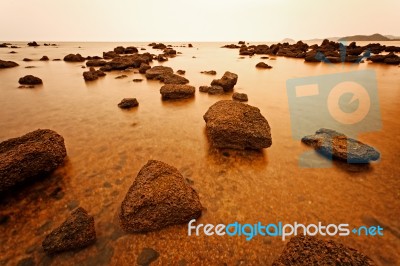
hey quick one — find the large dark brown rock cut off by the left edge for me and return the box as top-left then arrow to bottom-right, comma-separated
0,129 -> 67,191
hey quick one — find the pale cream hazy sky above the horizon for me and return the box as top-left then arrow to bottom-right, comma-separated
0,0 -> 400,42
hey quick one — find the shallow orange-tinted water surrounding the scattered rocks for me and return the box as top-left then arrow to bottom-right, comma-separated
0,42 -> 400,265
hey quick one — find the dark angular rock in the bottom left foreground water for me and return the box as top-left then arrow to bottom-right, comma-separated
42,207 -> 96,254
